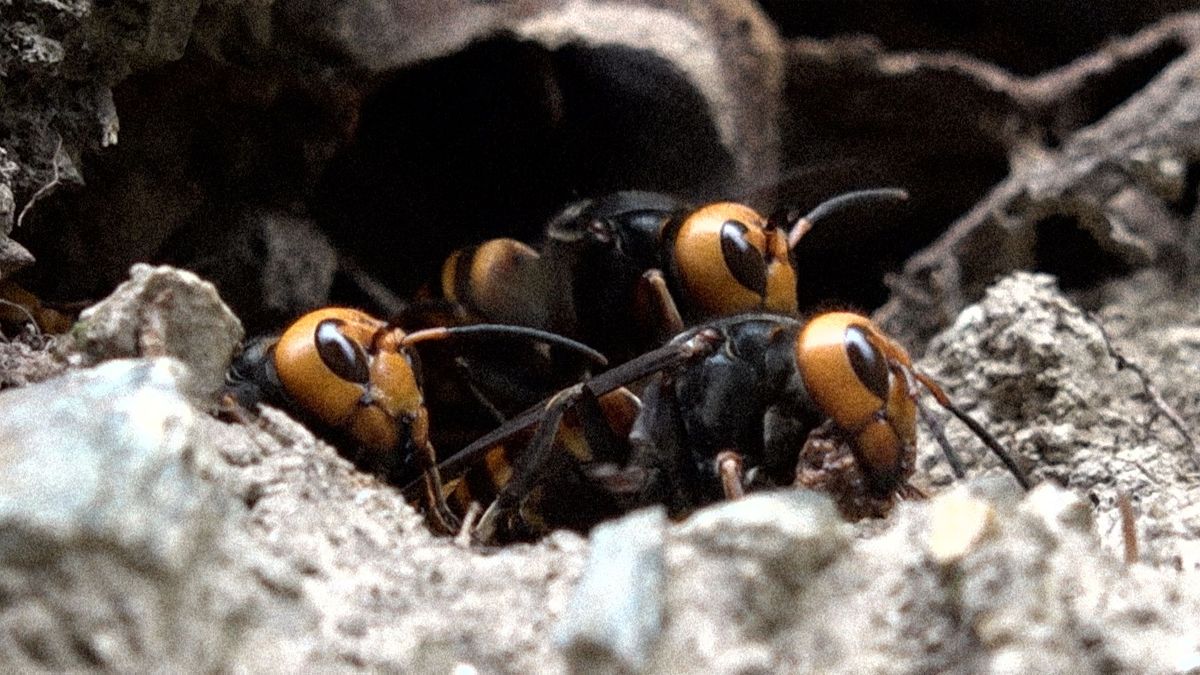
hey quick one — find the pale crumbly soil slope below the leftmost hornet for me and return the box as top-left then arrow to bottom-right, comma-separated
187,401 -> 586,673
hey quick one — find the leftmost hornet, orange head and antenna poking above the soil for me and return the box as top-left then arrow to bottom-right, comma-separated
226,307 -> 606,527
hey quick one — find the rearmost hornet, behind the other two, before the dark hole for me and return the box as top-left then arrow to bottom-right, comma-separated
427,189 -> 907,363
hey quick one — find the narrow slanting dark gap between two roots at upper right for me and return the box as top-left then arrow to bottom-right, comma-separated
1045,41 -> 1187,148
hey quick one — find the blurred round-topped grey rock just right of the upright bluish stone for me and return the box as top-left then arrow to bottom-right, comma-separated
650,490 -> 851,673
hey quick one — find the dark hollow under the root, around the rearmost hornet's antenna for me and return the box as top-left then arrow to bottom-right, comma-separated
781,60 -> 1008,310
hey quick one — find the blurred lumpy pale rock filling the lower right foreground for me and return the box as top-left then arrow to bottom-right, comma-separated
825,484 -> 1200,673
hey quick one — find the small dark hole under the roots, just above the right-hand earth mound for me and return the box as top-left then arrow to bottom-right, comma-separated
1034,214 -> 1130,285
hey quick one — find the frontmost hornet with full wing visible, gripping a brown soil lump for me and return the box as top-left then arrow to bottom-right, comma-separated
406,312 -> 1030,542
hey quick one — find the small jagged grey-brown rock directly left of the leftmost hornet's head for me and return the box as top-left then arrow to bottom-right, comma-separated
64,263 -> 242,396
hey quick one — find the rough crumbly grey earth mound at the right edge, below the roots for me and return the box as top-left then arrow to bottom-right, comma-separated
924,271 -> 1200,569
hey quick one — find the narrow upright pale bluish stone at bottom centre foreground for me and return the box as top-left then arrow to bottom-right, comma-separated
554,508 -> 667,673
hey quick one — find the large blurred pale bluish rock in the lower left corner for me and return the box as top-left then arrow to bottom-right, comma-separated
0,359 -> 247,670
